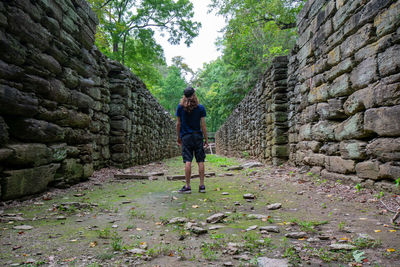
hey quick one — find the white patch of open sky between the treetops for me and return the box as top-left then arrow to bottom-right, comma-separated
156,0 -> 226,71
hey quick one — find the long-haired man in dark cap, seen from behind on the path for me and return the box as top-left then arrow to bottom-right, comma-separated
175,86 -> 208,194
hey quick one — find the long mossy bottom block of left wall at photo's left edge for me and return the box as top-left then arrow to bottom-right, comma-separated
1,164 -> 60,200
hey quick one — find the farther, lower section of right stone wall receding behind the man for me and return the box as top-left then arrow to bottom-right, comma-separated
216,57 -> 289,164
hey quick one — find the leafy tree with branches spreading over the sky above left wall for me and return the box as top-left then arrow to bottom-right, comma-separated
89,0 -> 201,63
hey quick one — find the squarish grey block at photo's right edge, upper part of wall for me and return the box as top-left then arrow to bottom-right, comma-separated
378,44 -> 400,77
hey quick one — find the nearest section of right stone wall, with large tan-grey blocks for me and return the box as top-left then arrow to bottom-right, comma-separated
217,0 -> 400,193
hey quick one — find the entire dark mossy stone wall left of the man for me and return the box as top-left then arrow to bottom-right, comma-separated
0,0 -> 179,200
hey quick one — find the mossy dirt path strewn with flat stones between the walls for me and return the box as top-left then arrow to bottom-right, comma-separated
0,156 -> 400,267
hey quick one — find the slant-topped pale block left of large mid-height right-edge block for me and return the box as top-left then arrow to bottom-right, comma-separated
335,113 -> 371,141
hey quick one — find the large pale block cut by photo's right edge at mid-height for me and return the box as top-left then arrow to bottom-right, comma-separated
364,105 -> 400,136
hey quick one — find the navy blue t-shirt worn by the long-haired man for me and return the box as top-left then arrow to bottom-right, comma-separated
175,104 -> 206,137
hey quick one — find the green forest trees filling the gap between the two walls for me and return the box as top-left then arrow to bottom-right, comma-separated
89,0 -> 306,132
